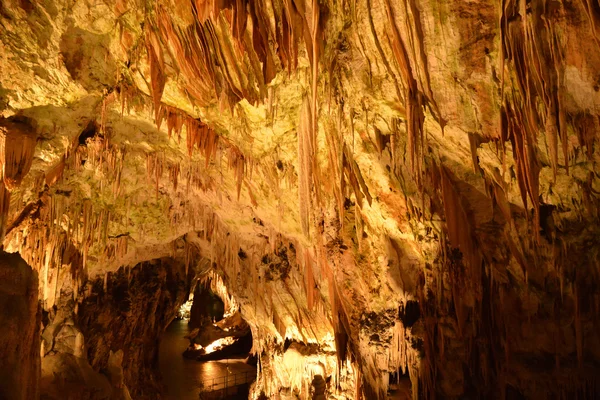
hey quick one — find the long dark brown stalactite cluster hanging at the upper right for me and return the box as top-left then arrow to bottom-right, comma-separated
500,0 -> 569,241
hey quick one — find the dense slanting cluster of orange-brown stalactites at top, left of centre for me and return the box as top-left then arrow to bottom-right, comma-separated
157,0 -> 310,105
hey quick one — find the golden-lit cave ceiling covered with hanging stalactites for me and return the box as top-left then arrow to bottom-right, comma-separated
0,0 -> 600,394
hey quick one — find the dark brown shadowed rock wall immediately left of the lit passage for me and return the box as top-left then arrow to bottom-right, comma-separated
77,258 -> 190,399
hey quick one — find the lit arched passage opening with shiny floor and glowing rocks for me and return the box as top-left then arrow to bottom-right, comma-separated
159,274 -> 256,399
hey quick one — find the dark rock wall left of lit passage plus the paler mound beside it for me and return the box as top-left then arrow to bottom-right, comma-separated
38,253 -> 193,400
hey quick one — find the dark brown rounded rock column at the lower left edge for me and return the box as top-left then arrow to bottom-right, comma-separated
0,251 -> 41,400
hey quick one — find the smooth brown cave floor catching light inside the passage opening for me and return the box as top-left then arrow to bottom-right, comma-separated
158,320 -> 256,400
